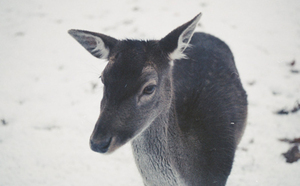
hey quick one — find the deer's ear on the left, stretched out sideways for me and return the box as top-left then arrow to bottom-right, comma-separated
68,30 -> 118,59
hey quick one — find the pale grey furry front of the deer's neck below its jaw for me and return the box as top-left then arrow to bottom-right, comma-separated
132,76 -> 181,185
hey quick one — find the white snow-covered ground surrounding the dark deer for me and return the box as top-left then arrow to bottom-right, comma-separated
0,0 -> 300,186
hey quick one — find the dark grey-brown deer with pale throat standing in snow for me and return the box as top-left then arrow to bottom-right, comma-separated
68,13 -> 248,186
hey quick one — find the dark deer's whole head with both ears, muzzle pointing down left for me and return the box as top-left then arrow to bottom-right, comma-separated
69,14 -> 201,153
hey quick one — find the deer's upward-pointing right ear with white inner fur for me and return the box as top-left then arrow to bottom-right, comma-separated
159,13 -> 201,60
